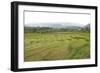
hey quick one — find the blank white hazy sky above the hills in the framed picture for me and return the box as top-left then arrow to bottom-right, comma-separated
24,12 -> 90,26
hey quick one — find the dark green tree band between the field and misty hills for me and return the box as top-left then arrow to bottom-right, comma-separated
24,24 -> 90,33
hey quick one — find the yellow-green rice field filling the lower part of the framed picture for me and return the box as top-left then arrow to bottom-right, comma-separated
24,32 -> 90,62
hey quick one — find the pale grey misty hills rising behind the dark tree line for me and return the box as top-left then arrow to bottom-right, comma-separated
25,23 -> 83,28
